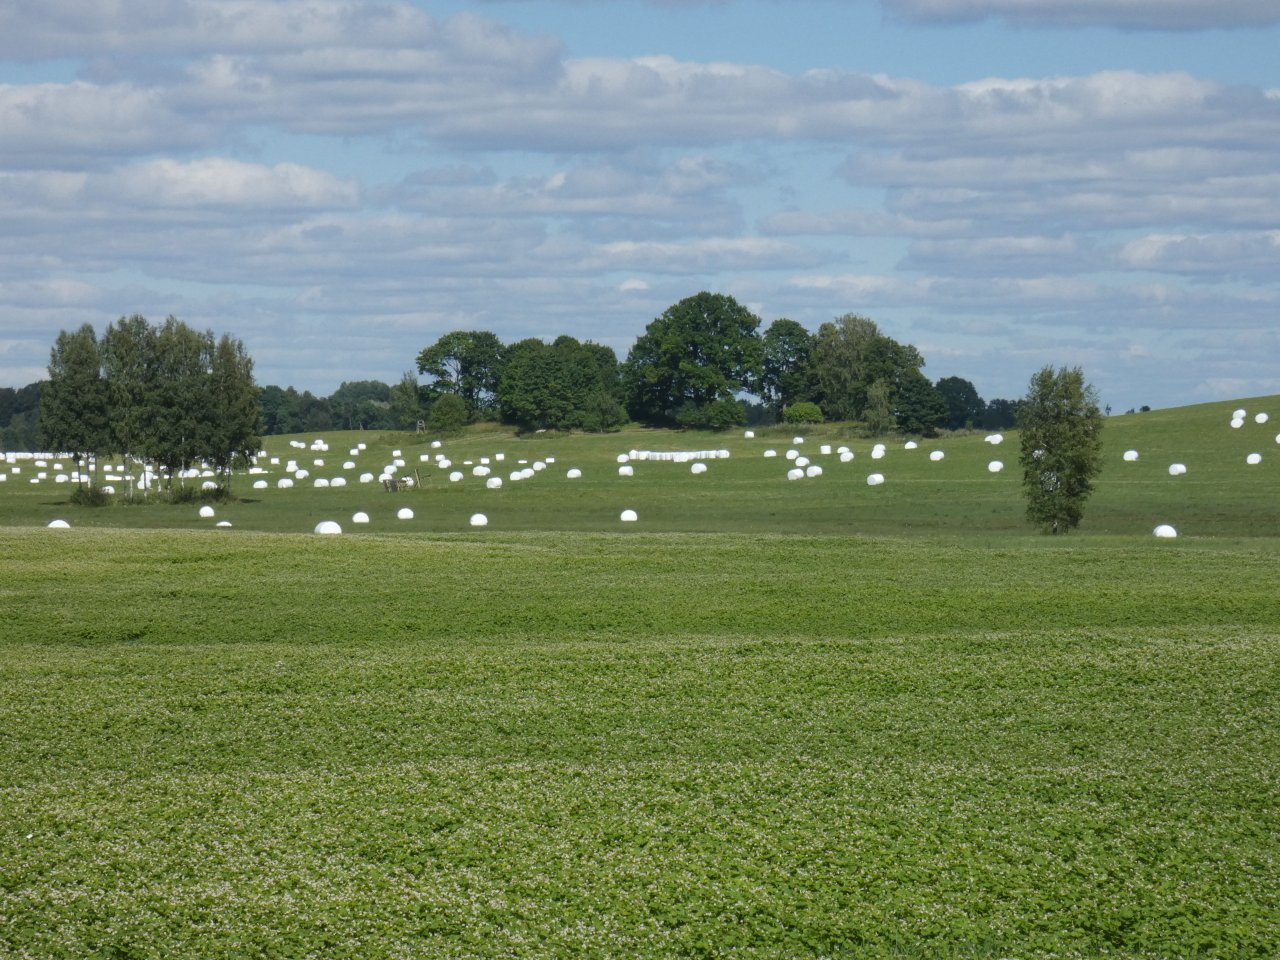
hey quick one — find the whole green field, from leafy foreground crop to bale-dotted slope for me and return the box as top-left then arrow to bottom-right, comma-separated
0,398 -> 1280,959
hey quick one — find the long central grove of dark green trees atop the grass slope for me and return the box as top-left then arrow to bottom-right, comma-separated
391,292 -> 1018,435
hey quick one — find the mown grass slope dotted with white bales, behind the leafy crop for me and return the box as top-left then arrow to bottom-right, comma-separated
0,397 -> 1280,538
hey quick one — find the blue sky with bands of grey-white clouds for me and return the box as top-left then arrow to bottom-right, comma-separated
0,0 -> 1280,412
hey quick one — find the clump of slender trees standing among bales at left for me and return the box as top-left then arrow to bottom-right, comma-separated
38,315 -> 261,491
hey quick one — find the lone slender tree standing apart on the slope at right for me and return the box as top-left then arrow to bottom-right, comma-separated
1018,366 -> 1102,534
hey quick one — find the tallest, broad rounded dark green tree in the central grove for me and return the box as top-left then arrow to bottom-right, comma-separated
623,292 -> 763,425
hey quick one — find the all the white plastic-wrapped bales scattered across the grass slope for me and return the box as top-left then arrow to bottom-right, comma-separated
17,410 -> 1280,538
